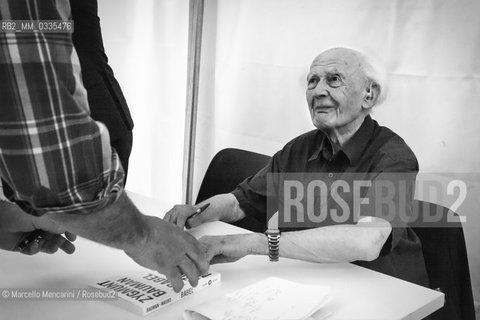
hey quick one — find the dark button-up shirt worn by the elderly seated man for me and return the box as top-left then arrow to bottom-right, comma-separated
233,116 -> 428,286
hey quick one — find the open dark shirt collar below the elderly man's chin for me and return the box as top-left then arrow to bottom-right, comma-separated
308,115 -> 375,164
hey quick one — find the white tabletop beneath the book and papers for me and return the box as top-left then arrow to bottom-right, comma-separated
0,194 -> 444,320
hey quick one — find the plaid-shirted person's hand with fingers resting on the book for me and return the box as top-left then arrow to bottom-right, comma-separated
125,216 -> 209,292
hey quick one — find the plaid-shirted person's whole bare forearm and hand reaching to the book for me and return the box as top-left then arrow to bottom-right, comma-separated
43,191 -> 209,292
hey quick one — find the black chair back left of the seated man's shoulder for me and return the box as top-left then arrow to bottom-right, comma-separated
196,148 -> 270,232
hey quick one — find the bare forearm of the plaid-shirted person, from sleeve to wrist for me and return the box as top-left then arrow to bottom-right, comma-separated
47,191 -> 149,251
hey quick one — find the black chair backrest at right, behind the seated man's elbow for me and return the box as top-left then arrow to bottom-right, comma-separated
411,200 -> 475,320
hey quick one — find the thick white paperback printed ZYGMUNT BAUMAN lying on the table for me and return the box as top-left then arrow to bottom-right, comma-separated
90,272 -> 220,315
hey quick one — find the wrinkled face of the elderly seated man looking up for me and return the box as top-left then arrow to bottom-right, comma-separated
306,49 -> 367,130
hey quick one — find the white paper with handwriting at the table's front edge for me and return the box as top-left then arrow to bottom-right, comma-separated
184,277 -> 329,320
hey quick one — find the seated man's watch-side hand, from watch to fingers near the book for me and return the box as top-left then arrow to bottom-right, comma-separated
199,233 -> 268,264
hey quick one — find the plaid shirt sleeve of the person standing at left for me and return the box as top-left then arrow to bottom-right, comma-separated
0,0 -> 124,216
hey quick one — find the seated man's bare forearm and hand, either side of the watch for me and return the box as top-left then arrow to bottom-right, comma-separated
212,219 -> 391,263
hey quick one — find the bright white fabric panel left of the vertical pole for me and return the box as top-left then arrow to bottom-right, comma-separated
98,0 -> 188,205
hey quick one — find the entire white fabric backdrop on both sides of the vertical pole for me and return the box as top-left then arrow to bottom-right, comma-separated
99,0 -> 480,316
